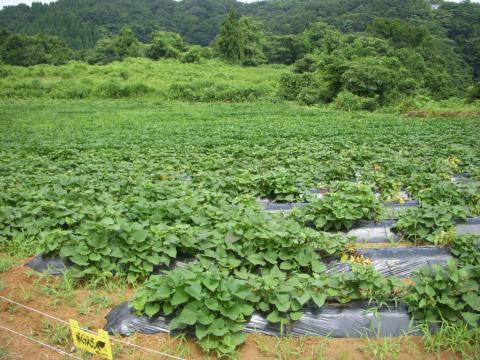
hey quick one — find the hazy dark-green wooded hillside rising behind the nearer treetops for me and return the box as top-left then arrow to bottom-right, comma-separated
0,0 -> 438,48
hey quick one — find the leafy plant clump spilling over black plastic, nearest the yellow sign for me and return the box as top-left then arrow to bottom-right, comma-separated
133,265 -> 259,355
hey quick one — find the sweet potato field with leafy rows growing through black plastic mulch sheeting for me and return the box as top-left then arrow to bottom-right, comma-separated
0,100 -> 480,358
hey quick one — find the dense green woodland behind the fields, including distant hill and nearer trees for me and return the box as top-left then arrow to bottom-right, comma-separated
0,0 -> 480,110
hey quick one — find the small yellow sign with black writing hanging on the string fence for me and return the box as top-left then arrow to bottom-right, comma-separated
70,320 -> 113,360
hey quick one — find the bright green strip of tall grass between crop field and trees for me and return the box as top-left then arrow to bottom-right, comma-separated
0,58 -> 287,101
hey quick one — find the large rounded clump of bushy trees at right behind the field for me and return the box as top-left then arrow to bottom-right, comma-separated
280,19 -> 470,106
